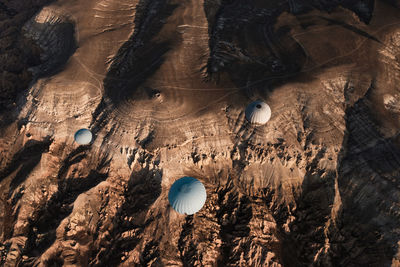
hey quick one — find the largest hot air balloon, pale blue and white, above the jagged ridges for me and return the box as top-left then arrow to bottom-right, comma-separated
168,176 -> 207,215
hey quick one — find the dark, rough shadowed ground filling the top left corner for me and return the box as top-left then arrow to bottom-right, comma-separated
0,0 -> 56,124
